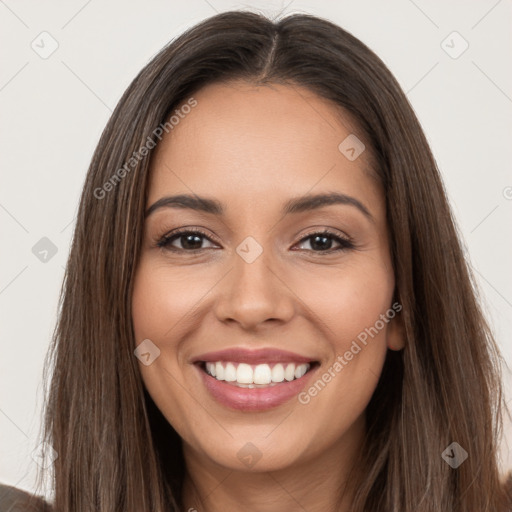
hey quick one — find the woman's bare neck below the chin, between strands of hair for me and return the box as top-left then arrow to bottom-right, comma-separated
182,418 -> 364,512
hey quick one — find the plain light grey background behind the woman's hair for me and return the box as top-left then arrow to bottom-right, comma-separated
0,0 -> 512,498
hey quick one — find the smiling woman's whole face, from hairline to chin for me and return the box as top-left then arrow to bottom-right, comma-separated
132,82 -> 403,471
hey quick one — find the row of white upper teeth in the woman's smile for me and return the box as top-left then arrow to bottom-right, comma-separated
206,361 -> 311,388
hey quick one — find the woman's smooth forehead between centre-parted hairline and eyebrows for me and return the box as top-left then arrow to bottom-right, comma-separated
148,81 -> 379,217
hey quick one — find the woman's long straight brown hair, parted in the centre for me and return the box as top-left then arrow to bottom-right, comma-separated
34,12 -> 505,512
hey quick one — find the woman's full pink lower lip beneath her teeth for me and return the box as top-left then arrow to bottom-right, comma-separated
196,365 -> 317,411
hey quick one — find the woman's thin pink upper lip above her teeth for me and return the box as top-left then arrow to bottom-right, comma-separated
192,347 -> 315,364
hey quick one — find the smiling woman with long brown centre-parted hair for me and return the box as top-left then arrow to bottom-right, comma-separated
6,8 -> 512,512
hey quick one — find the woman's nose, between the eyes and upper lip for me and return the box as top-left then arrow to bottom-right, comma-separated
214,245 -> 295,330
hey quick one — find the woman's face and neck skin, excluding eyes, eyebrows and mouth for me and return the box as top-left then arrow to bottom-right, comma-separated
132,82 -> 404,512
